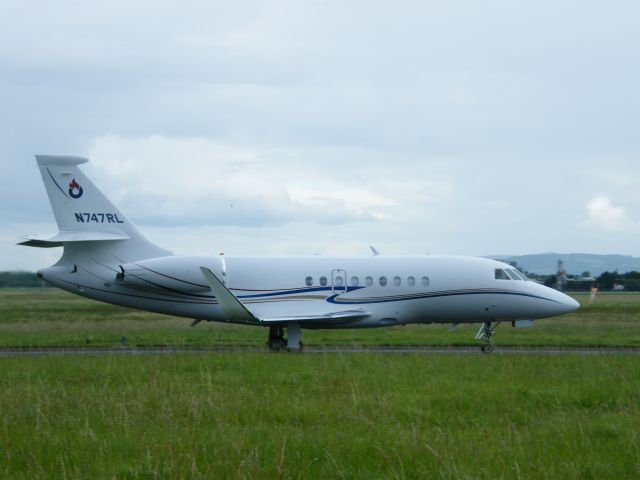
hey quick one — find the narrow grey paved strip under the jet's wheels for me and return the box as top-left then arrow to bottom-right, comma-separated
0,346 -> 640,358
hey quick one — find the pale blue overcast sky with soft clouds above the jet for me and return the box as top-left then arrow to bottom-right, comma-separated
0,0 -> 640,270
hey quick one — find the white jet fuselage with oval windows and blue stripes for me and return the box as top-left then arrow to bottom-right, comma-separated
41,255 -> 578,328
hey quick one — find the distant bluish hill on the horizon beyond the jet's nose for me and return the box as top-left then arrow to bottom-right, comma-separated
490,253 -> 640,276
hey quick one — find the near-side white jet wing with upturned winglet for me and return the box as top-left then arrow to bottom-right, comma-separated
200,267 -> 370,325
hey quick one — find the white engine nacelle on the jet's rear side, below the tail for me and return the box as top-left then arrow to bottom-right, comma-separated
116,257 -> 223,293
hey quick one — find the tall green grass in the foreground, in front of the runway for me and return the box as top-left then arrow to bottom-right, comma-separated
0,353 -> 640,479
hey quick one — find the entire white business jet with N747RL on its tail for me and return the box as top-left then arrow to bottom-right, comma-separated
20,155 -> 579,352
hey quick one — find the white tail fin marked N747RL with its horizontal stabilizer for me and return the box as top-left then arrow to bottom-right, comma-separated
21,155 -> 171,261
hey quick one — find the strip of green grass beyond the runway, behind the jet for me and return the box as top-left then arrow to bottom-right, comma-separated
0,288 -> 640,348
